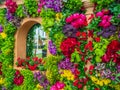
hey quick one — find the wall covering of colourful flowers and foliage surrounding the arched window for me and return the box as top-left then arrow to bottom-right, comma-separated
0,0 -> 120,90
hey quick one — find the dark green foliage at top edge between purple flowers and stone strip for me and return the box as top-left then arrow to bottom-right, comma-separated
64,0 -> 82,11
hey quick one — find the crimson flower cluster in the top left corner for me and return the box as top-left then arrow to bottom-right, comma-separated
5,0 -> 17,13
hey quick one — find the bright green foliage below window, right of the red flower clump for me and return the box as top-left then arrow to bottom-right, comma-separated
13,70 -> 35,90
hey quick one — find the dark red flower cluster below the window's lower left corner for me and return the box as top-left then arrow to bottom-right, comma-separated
14,70 -> 24,86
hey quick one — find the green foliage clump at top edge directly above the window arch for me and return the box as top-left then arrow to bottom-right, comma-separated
24,0 -> 38,17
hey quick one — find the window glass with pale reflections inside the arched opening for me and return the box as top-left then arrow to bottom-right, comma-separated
26,24 -> 47,58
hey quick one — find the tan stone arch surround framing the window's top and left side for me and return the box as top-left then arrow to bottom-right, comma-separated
14,18 -> 48,70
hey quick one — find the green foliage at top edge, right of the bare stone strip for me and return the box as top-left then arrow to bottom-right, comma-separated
91,0 -> 115,11
